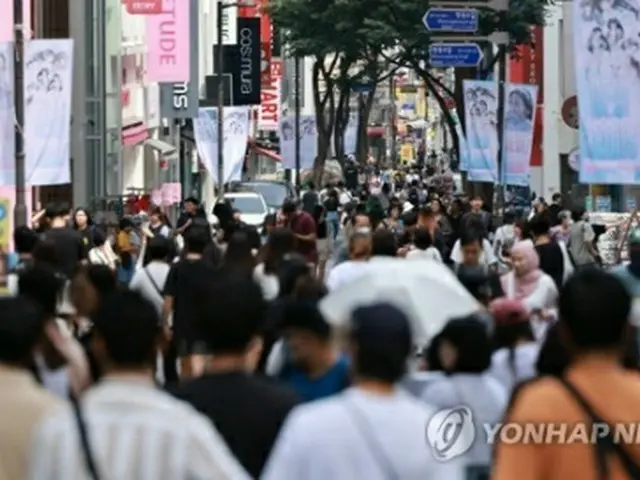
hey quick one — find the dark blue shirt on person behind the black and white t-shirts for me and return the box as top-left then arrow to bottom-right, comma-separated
280,355 -> 350,402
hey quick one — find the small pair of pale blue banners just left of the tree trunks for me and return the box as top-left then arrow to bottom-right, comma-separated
280,115 -> 318,170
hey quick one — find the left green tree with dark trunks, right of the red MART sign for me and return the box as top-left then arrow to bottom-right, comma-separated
270,0 -> 395,175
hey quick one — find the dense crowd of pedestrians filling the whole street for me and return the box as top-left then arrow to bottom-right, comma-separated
0,168 -> 640,480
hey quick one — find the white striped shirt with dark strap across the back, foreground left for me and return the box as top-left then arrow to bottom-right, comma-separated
29,376 -> 250,480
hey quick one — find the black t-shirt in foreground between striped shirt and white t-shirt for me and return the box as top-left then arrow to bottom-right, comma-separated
171,372 -> 300,478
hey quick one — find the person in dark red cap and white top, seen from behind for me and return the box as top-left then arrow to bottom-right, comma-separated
489,298 -> 540,392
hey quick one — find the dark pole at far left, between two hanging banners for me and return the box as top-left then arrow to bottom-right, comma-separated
13,0 -> 28,228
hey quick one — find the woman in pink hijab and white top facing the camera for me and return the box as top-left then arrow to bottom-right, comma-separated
500,240 -> 558,338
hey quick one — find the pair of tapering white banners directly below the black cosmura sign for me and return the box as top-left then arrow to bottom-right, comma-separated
193,107 -> 249,183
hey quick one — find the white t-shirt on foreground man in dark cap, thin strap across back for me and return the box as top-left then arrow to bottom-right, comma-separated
261,388 -> 464,480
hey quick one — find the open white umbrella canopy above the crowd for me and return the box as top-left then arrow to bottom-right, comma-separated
320,258 -> 481,346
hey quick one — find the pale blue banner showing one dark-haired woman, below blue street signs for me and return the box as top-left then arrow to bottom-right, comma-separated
502,83 -> 538,187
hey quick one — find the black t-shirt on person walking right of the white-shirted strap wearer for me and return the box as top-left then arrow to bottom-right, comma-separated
163,258 -> 218,345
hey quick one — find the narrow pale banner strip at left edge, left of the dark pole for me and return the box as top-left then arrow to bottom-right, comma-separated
0,42 -> 15,185
